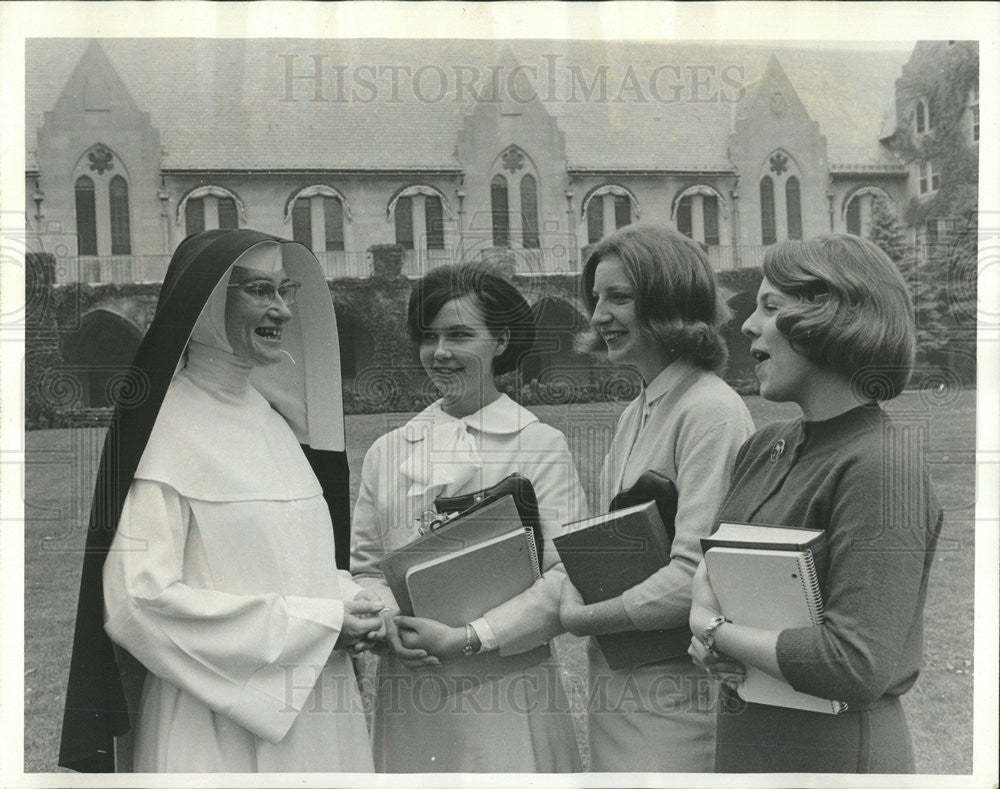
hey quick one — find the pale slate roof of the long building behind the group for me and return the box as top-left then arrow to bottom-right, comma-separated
25,39 -> 908,171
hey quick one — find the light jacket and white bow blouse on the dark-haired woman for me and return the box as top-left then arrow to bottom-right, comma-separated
351,395 -> 587,654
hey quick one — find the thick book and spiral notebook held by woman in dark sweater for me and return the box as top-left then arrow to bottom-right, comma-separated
701,523 -> 847,714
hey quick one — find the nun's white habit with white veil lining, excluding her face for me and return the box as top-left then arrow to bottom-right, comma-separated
64,231 -> 372,772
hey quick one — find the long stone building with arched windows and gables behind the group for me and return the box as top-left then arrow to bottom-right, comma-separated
25,39 -> 960,405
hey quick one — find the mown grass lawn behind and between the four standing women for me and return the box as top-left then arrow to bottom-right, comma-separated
24,391 -> 975,774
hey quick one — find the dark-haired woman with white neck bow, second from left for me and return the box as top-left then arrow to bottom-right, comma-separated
351,264 -> 586,773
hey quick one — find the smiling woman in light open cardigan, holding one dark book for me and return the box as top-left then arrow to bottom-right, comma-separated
561,225 -> 753,772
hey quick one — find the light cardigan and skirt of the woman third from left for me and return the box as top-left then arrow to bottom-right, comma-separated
587,360 -> 753,773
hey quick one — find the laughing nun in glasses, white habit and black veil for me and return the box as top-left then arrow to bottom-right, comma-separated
59,230 -> 381,772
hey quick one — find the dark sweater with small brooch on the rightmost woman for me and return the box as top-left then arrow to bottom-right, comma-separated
719,405 -> 941,709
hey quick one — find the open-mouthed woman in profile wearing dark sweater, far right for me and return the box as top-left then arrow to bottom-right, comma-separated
690,235 -> 941,773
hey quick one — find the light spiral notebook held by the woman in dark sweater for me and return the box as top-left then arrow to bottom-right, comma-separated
705,548 -> 847,714
